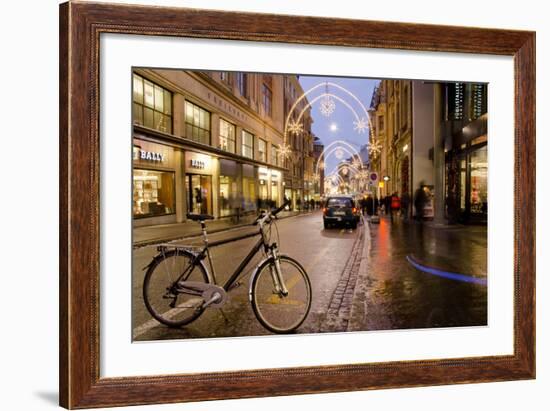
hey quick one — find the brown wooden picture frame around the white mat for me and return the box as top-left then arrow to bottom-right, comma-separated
59,2 -> 535,409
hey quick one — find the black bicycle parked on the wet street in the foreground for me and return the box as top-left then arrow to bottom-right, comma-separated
143,202 -> 312,334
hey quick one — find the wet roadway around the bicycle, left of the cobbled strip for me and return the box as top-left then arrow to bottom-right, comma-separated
133,211 -> 364,340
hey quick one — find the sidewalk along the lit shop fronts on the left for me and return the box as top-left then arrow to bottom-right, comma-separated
132,211 -> 310,248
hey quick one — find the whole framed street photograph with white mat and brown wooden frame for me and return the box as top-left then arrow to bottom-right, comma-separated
60,2 -> 535,409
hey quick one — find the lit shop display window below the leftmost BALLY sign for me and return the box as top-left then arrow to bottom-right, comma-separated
133,169 -> 175,217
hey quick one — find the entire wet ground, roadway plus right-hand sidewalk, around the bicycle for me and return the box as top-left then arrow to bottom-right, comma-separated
132,211 -> 487,341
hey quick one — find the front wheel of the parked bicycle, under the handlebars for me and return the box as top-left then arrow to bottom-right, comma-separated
251,256 -> 312,334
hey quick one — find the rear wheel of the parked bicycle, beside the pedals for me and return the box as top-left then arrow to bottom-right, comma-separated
143,250 -> 210,327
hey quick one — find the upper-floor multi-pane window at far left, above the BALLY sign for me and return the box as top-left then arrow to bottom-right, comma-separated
133,74 -> 172,133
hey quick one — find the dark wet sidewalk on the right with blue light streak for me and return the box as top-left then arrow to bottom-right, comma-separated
360,217 -> 487,330
